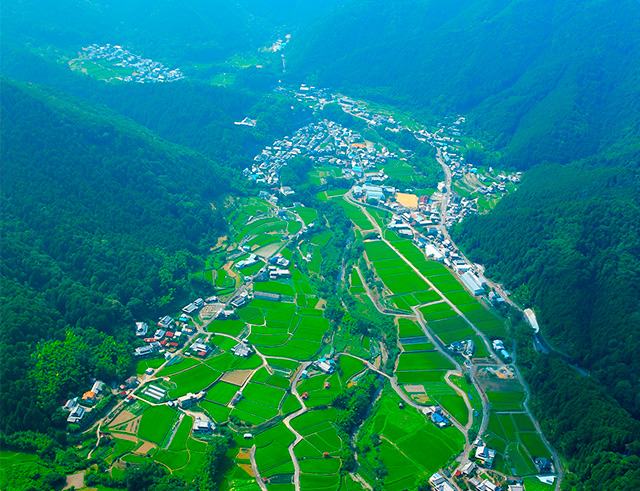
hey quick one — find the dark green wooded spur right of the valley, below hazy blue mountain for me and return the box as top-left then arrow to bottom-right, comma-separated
457,160 -> 640,417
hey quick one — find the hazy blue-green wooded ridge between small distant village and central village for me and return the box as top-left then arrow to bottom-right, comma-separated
1,44 -> 309,168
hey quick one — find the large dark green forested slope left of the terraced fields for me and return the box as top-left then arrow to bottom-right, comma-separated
0,81 -> 232,432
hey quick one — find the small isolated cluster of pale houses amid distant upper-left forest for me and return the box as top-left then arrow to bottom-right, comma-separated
74,44 -> 184,83
